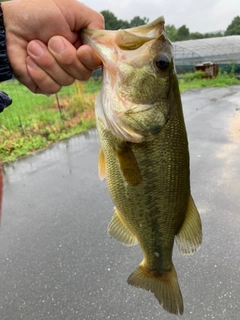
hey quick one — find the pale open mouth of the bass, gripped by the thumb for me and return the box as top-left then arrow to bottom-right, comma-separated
81,16 -> 165,64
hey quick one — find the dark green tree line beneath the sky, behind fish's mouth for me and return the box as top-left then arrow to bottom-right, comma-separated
101,10 -> 240,41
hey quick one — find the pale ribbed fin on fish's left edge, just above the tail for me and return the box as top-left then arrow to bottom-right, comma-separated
108,208 -> 137,246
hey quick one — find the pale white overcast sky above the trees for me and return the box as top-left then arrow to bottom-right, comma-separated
84,0 -> 240,33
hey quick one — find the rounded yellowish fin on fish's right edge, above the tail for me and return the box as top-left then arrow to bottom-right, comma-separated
176,195 -> 202,255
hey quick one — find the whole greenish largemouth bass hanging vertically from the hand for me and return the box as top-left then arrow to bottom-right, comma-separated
83,17 -> 202,314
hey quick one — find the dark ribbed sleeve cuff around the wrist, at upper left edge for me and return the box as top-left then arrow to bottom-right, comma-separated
0,2 -> 12,82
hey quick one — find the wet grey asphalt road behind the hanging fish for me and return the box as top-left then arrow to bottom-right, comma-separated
0,87 -> 240,320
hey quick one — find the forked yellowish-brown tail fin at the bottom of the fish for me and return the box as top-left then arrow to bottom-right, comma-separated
128,263 -> 183,314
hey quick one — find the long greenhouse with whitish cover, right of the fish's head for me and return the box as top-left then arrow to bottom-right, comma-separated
173,35 -> 240,73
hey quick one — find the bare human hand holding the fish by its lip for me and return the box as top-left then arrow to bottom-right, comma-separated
2,0 -> 104,94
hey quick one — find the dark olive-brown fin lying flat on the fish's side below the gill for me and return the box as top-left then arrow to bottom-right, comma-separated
115,142 -> 142,185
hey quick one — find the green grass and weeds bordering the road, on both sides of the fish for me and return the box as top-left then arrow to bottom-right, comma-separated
0,66 -> 240,162
